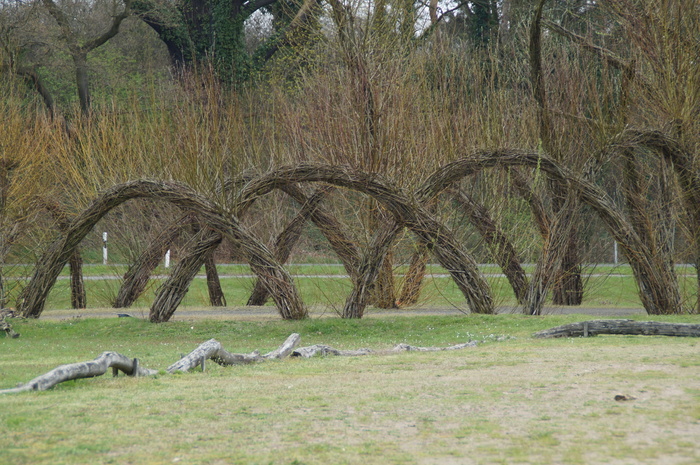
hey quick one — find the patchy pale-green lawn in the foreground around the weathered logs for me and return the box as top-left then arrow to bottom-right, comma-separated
0,315 -> 700,465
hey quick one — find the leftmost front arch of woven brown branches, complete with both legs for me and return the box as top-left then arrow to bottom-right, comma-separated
18,180 -> 307,319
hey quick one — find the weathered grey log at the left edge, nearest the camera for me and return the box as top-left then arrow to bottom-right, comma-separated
0,352 -> 158,394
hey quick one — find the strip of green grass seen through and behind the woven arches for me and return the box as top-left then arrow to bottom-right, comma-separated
7,264 -> 696,311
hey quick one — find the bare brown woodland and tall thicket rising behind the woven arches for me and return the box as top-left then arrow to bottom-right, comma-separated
0,0 -> 700,321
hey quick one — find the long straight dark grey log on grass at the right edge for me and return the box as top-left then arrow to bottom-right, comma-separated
532,320 -> 700,338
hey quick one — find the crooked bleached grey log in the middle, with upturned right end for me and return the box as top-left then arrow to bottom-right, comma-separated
167,333 -> 301,373
